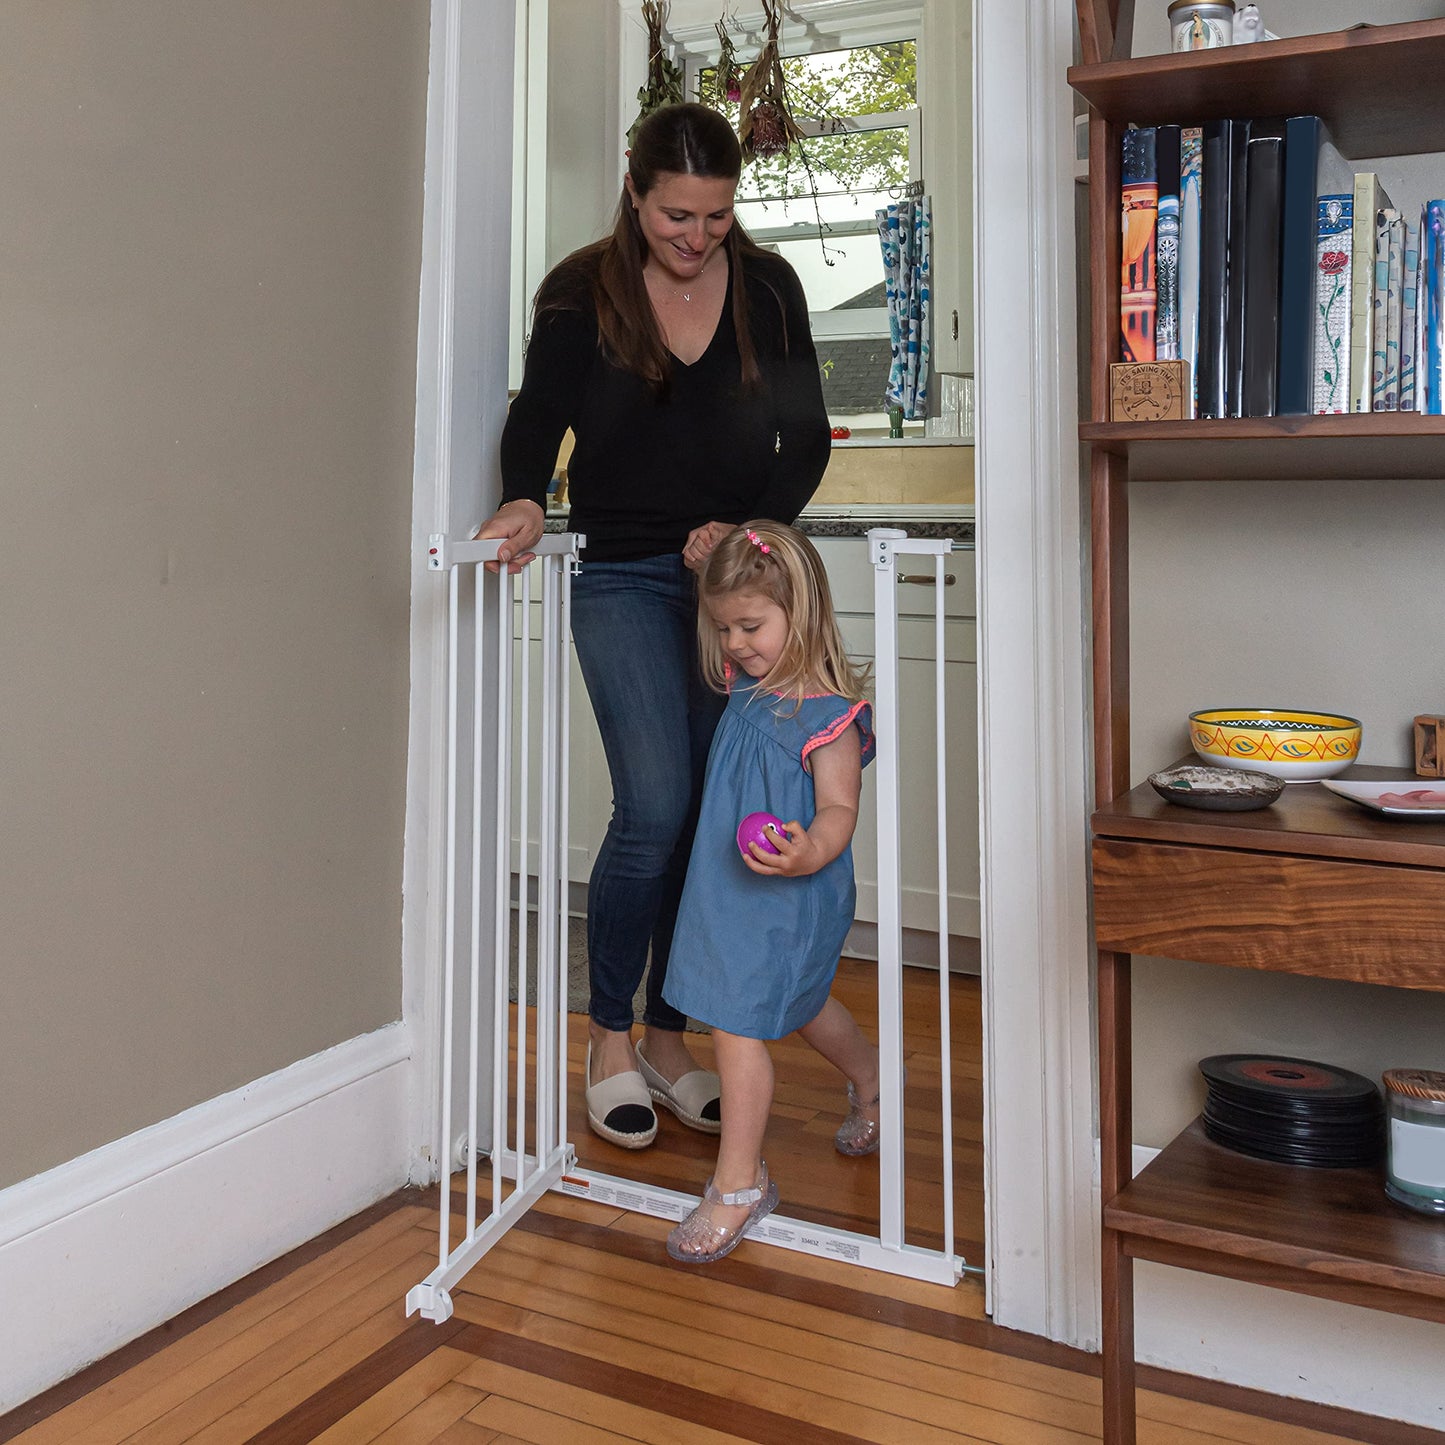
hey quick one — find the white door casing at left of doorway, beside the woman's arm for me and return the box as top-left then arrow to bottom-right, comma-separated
402,0 -> 516,1183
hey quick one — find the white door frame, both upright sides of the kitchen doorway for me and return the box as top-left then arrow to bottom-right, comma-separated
403,0 -> 1097,1345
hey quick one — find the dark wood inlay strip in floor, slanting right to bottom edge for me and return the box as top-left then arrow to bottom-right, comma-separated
447,1325 -> 863,1445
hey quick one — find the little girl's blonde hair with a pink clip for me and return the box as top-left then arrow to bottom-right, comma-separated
698,519 -> 868,704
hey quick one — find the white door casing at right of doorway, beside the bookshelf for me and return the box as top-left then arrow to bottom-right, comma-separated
974,0 -> 1097,1347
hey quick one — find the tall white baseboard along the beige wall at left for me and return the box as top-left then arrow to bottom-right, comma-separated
0,1023 -> 412,1412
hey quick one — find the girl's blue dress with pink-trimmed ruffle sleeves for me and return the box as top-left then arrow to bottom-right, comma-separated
663,679 -> 873,1039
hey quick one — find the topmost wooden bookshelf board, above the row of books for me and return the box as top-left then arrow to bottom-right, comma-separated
1068,20 -> 1445,158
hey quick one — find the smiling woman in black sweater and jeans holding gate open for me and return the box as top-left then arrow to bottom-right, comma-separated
478,104 -> 829,1149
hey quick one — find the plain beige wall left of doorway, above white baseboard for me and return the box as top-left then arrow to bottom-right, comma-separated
0,0 -> 428,1186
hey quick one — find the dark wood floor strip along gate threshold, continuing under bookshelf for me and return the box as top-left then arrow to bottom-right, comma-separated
517,1211 -> 1445,1445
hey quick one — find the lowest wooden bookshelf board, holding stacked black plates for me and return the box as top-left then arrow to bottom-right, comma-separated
1104,1120 -> 1445,1321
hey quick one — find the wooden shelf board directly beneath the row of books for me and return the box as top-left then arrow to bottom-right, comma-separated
1079,416 -> 1445,481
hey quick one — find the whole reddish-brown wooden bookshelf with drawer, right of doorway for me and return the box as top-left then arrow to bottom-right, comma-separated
1069,0 -> 1445,1445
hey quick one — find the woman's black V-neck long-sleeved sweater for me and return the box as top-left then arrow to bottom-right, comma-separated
501,245 -> 829,561
